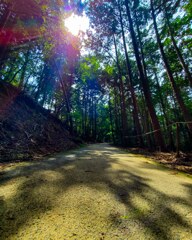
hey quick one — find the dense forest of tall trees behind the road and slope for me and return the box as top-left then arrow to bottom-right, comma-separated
0,0 -> 192,151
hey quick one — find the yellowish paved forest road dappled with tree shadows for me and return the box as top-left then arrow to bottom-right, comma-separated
0,144 -> 192,240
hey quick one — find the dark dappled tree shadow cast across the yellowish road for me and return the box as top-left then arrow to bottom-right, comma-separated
0,144 -> 192,240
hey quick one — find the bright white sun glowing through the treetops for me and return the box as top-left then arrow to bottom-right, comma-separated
64,14 -> 89,36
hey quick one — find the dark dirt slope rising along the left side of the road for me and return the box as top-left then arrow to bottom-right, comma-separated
0,82 -> 76,162
